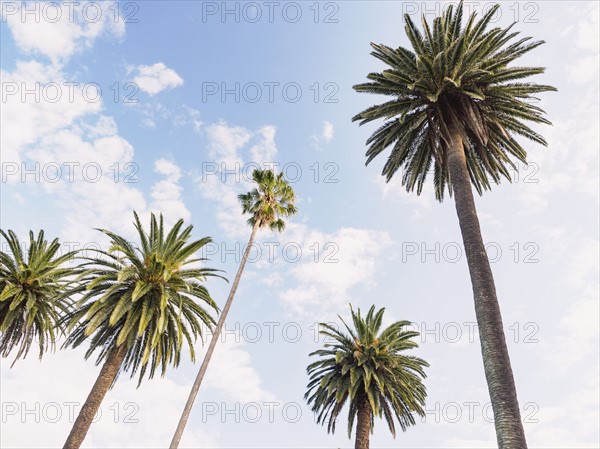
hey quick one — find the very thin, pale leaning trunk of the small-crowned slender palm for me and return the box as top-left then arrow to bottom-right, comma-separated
170,221 -> 259,449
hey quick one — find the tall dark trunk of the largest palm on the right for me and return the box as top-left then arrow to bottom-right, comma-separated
448,129 -> 527,449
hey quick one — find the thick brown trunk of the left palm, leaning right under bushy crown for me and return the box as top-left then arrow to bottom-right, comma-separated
63,344 -> 127,449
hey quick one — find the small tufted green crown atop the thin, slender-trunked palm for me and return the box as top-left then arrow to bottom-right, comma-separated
238,169 -> 297,232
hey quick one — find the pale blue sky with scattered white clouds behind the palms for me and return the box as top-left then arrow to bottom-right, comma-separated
0,1 -> 600,448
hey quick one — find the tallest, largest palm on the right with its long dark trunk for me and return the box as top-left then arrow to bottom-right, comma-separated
353,3 -> 556,449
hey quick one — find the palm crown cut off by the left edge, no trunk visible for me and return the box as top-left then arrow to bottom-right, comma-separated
0,229 -> 76,367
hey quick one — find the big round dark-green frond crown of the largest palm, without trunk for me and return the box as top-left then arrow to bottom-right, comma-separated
352,2 -> 556,201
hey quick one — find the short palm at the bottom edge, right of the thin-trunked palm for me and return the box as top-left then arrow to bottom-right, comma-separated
304,306 -> 429,449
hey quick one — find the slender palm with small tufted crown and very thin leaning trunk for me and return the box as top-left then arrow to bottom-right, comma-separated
170,169 -> 296,449
